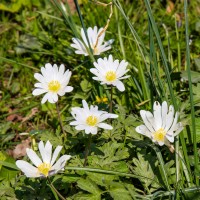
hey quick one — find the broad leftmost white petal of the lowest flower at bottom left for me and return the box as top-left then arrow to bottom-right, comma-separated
16,160 -> 40,177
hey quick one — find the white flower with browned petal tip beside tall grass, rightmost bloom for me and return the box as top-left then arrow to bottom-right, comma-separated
136,101 -> 183,146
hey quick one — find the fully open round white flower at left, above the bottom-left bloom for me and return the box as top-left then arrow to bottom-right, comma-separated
32,63 -> 73,104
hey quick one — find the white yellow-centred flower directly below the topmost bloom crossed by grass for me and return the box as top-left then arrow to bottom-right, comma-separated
90,55 -> 130,92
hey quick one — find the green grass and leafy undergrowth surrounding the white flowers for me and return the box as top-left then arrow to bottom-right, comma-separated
0,0 -> 200,200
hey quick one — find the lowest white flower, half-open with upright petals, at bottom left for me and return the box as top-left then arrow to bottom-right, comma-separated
16,141 -> 71,177
